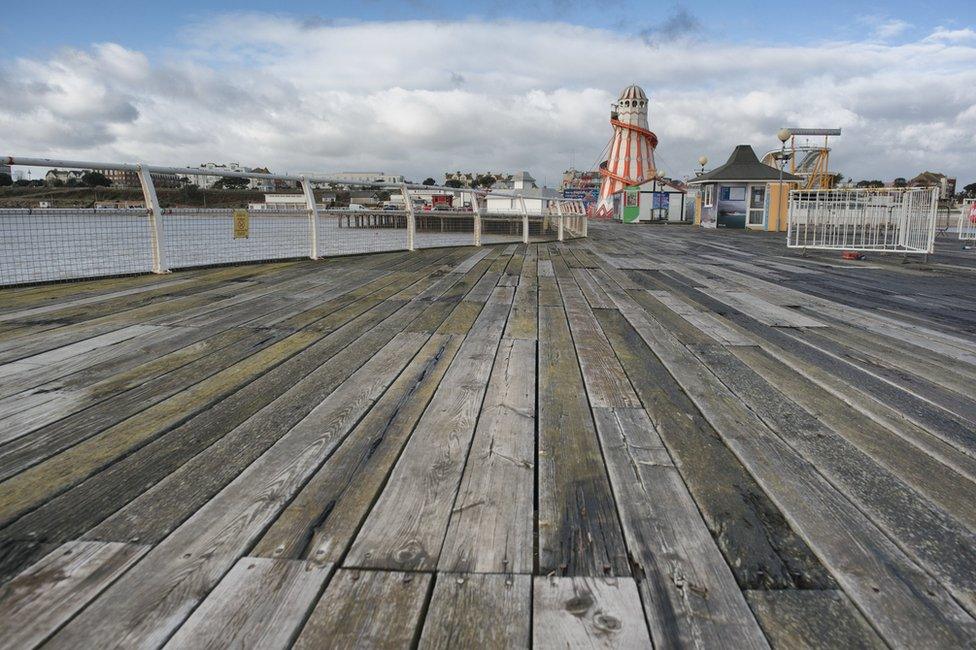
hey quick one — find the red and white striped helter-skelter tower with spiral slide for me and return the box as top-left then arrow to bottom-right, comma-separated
593,86 -> 657,219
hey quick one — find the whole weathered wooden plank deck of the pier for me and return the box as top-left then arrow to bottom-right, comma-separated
0,224 -> 976,649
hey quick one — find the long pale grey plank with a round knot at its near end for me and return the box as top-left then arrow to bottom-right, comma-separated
345,287 -> 513,570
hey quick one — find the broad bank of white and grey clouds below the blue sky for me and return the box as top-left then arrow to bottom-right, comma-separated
0,13 -> 976,183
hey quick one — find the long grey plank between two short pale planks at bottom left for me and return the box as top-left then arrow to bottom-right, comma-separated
44,334 -> 426,647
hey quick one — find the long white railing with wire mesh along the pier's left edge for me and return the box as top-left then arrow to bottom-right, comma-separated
0,157 -> 587,286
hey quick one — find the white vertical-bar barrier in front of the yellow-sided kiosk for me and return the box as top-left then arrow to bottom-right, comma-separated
787,188 -> 938,253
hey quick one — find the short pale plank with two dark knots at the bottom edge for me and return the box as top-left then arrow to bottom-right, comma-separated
532,576 -> 652,648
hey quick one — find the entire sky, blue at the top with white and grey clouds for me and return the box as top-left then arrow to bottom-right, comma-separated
0,0 -> 976,184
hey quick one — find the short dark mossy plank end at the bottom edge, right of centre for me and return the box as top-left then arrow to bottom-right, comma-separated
745,589 -> 887,650
